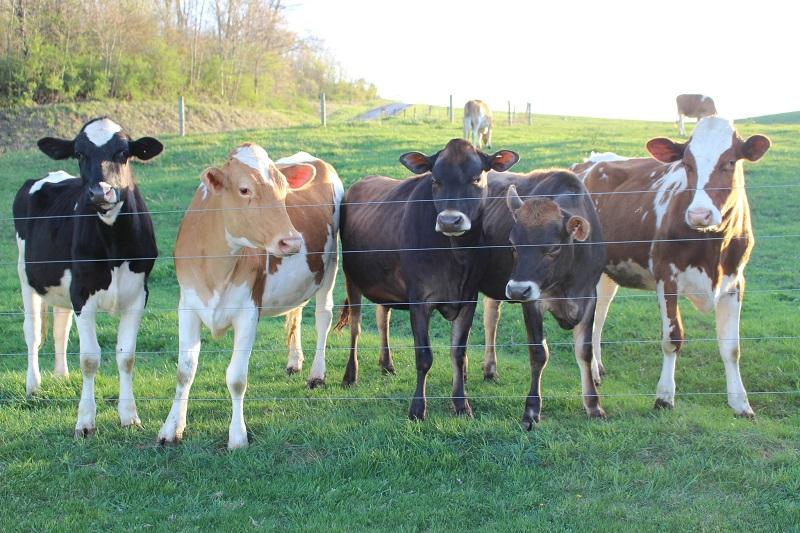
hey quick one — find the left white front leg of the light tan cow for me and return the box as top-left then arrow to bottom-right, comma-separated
158,306 -> 201,445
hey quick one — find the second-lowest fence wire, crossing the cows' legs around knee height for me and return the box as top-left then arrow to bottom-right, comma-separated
0,335 -> 800,357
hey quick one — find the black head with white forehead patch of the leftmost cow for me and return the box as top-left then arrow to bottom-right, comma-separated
37,117 -> 164,224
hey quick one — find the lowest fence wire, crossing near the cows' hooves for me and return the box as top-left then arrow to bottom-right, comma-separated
0,389 -> 800,404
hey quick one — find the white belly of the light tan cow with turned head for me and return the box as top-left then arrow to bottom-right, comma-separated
261,247 -> 329,316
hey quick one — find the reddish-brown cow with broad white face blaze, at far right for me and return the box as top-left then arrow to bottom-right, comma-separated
575,117 -> 770,416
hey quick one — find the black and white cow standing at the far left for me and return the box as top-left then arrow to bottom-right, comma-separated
14,117 -> 163,436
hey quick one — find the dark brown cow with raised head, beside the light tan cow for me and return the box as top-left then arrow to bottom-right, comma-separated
339,139 -> 519,420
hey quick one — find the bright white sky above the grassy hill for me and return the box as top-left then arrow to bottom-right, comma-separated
287,0 -> 800,120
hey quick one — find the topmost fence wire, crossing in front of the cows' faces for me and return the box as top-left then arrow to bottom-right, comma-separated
7,180 -> 800,222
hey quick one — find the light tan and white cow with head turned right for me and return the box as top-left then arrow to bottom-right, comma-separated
158,143 -> 344,449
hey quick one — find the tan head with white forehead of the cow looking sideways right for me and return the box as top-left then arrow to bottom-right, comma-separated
201,143 -> 306,257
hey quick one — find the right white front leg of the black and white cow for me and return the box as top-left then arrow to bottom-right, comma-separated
117,291 -> 145,427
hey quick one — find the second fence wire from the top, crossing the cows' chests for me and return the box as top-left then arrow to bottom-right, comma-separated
0,233 -> 800,266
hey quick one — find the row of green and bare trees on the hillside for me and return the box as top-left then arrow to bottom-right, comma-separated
0,0 -> 377,107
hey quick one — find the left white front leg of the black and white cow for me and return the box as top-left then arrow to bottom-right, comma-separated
75,302 -> 100,438
